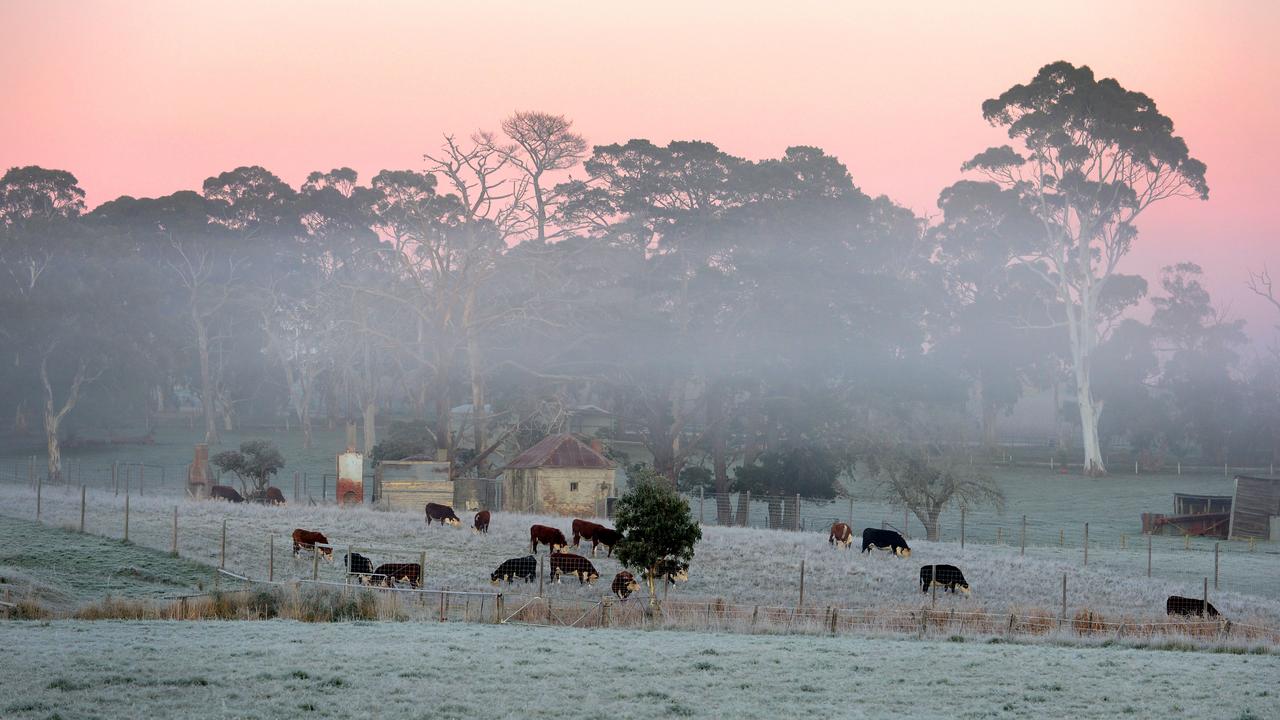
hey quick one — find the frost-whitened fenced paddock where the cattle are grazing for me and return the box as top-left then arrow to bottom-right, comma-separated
0,484 -> 1280,628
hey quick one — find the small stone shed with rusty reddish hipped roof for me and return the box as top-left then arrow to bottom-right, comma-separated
502,433 -> 616,518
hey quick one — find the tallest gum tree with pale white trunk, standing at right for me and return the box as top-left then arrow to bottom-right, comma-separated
961,61 -> 1208,475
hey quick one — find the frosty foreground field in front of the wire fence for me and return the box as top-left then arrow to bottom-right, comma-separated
0,620 -> 1280,720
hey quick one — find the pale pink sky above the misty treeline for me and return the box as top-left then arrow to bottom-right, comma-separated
0,0 -> 1280,336
